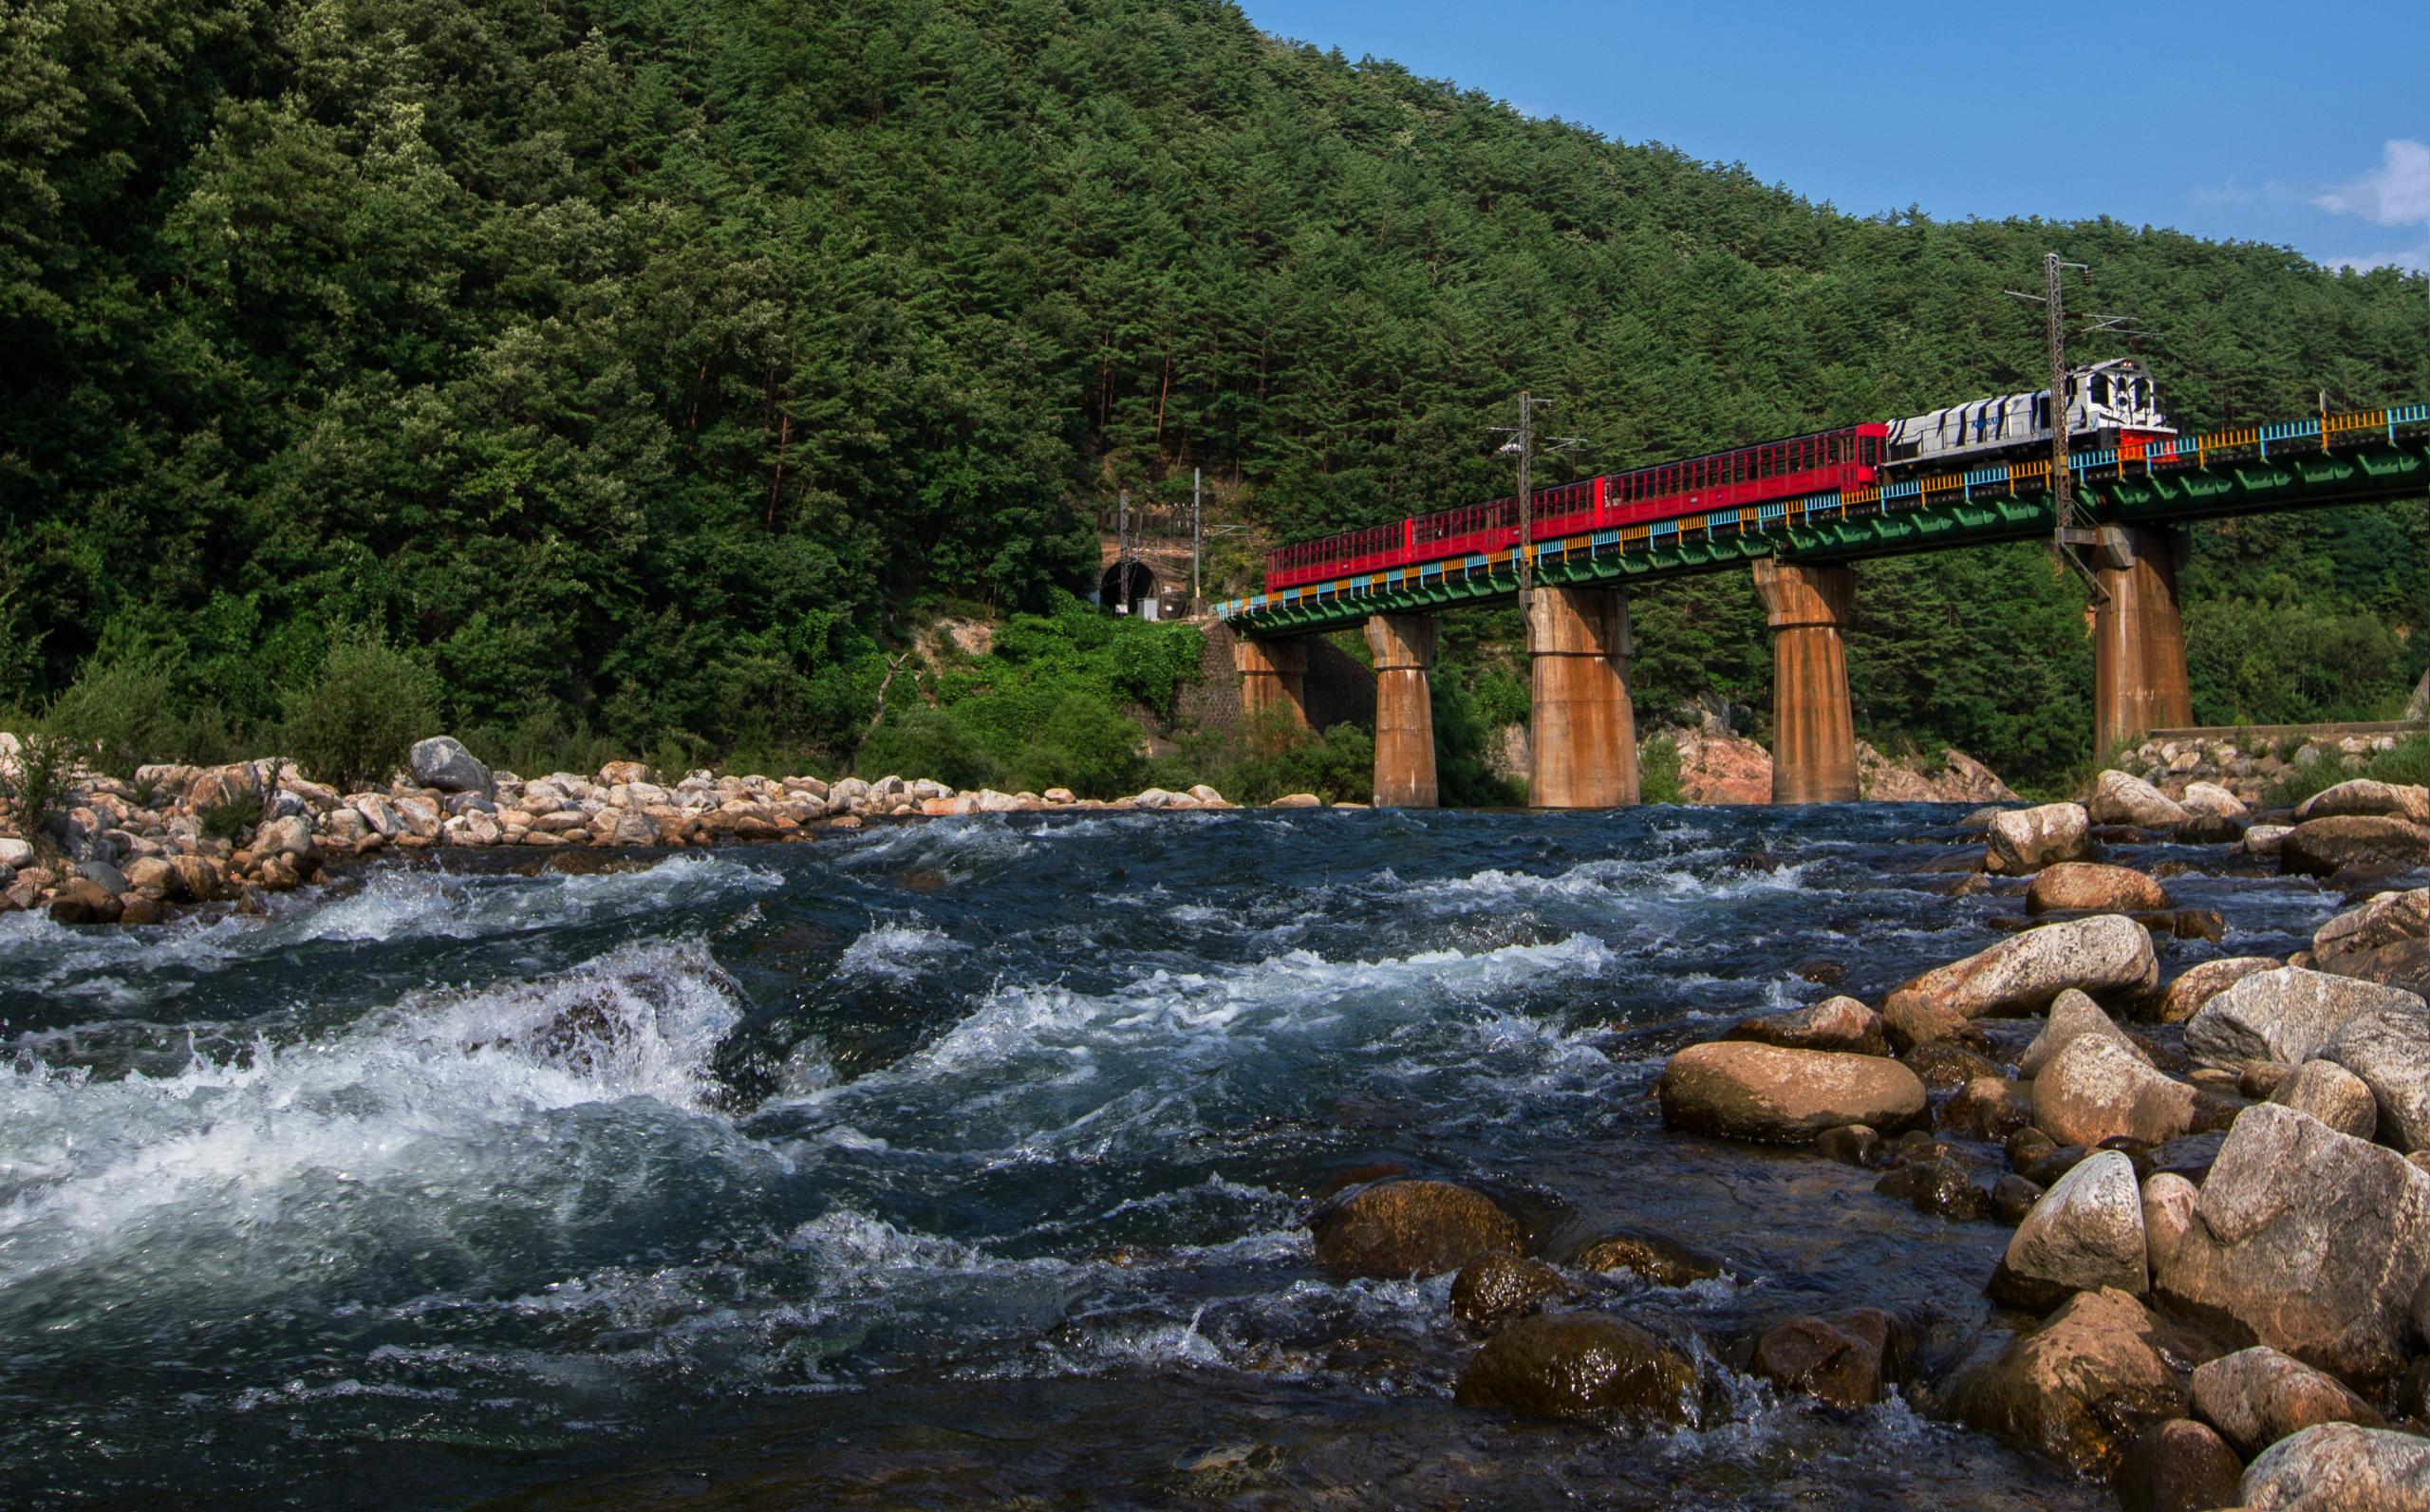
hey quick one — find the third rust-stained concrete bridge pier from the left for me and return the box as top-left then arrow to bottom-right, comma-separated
1526,588 -> 1637,810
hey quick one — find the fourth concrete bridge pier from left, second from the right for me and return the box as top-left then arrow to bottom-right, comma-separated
1754,556 -> 1857,802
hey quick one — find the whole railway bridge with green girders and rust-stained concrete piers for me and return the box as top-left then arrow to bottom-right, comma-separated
1215,403 -> 2430,810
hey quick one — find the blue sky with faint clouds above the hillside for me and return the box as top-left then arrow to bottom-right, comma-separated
1244,0 -> 2430,270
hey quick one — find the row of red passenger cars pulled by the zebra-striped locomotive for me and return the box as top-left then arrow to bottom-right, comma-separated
1266,425 -> 1888,593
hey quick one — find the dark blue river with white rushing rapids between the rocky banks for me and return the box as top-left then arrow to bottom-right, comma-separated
0,807 -> 2333,1507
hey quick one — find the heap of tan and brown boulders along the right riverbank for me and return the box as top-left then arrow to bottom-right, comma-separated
1310,771 -> 2430,1512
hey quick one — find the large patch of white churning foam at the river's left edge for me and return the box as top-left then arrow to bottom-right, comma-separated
0,943 -> 741,1300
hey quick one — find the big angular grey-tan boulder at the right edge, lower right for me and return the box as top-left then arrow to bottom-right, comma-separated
2156,1104 -> 2430,1378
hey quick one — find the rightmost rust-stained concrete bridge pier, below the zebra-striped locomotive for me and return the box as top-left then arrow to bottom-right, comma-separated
2092,525 -> 2195,756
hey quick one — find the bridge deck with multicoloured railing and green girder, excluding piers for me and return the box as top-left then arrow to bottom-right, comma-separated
1215,403 -> 2430,634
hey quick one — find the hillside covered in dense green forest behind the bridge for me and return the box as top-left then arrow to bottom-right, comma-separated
0,0 -> 2430,802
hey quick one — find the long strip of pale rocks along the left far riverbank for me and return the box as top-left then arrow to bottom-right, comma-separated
0,734 -> 1322,924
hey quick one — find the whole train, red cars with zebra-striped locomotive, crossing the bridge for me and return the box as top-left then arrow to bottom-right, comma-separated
1266,357 -> 2175,595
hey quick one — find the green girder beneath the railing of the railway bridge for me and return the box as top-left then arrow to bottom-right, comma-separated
1227,433 -> 2430,637
